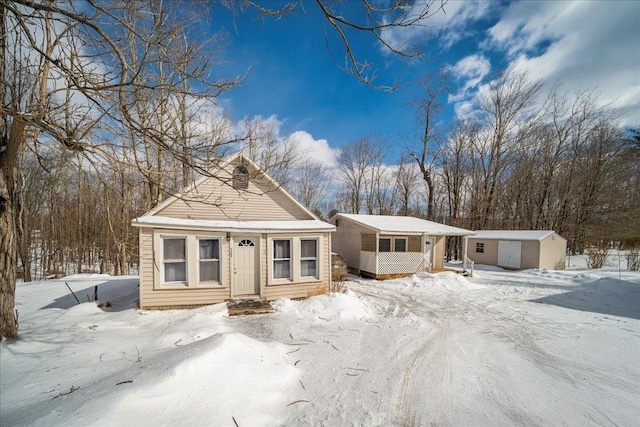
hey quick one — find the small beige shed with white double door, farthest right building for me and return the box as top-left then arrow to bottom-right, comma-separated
467,230 -> 567,270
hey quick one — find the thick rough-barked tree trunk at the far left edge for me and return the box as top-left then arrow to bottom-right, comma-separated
0,120 -> 25,339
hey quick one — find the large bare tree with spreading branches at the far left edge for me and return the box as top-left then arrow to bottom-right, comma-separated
0,0 -> 238,338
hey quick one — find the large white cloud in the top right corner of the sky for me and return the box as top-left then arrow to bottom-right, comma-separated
487,1 -> 640,125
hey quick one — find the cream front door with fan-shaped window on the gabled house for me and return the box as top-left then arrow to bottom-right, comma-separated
231,237 -> 260,297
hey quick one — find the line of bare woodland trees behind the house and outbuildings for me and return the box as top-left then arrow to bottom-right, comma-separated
19,70 -> 640,280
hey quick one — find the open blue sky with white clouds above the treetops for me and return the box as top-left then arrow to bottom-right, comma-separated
202,1 -> 640,164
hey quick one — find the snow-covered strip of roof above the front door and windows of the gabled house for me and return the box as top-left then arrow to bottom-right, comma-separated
131,216 -> 336,233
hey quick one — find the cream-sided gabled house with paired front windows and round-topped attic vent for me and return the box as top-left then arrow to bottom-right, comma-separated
132,152 -> 335,309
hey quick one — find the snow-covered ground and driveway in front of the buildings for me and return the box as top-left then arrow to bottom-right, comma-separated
0,257 -> 640,426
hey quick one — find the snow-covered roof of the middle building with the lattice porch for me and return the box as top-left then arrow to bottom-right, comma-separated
336,213 -> 473,236
